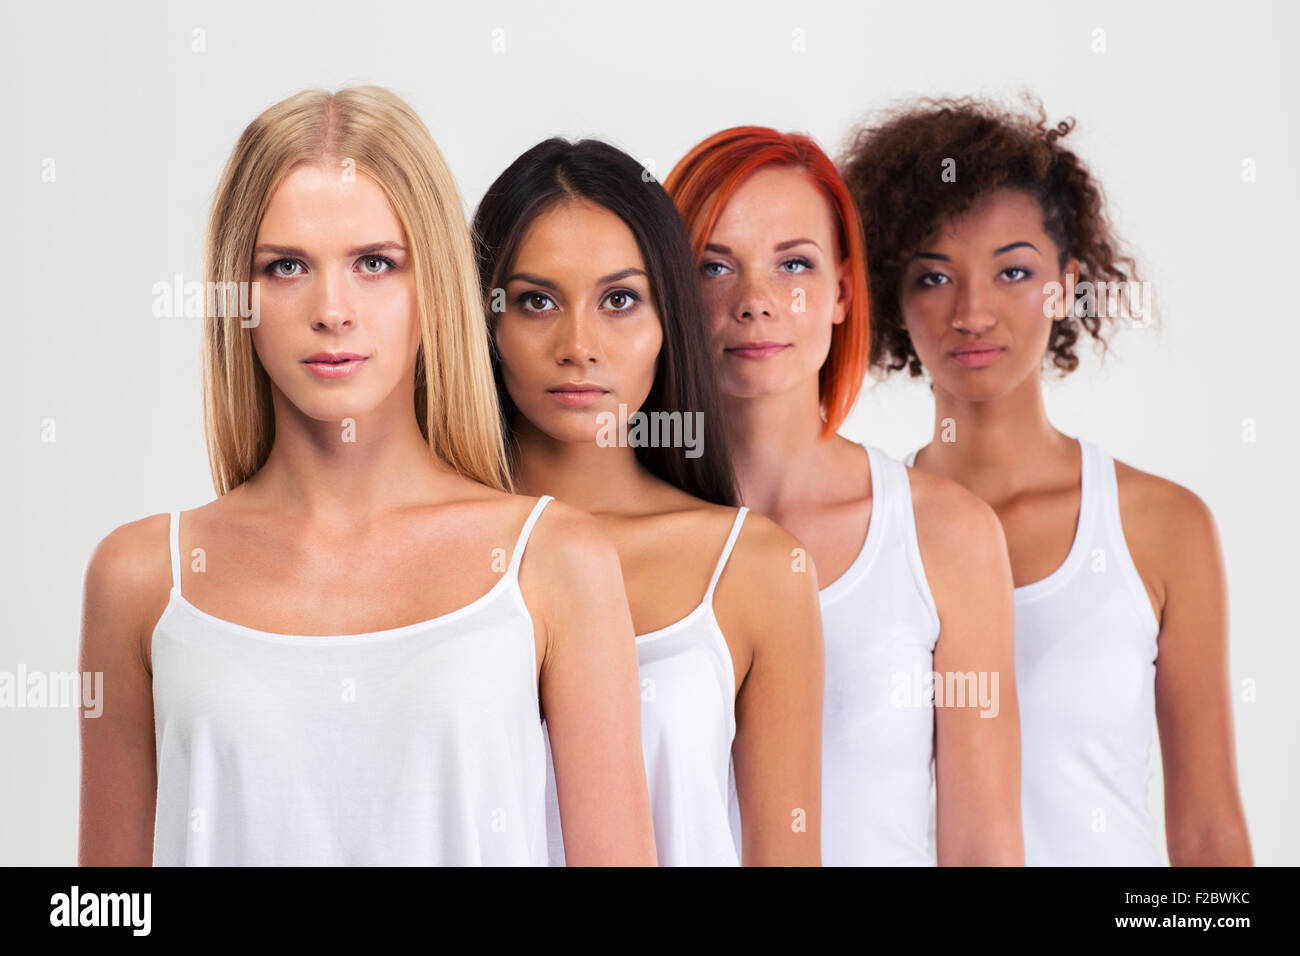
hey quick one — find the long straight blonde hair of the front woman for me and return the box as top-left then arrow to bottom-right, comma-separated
203,86 -> 511,494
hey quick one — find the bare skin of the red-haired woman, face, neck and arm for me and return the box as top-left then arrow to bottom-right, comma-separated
701,166 -> 1024,865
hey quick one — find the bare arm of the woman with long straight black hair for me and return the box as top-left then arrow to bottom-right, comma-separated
715,514 -> 826,866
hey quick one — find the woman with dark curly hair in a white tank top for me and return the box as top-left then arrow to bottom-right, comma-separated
844,100 -> 1251,865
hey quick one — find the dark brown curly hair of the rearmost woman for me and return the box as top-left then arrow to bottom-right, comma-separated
840,96 -> 1139,376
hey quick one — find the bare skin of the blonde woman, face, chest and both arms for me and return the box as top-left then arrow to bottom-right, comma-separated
79,161 -> 655,865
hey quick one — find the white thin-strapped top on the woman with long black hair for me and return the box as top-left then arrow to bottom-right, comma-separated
546,507 -> 749,866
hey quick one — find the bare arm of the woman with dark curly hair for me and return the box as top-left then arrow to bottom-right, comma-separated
1138,480 -> 1252,866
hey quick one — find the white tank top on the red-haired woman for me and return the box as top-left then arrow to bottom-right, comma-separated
732,445 -> 939,866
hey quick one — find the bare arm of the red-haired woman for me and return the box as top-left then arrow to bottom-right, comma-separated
907,468 -> 1024,866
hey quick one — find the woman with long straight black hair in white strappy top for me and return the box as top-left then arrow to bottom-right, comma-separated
473,139 -> 823,865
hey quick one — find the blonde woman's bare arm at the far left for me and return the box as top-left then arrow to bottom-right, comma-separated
78,515 -> 170,866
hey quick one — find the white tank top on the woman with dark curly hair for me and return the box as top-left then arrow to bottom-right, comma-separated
913,438 -> 1165,866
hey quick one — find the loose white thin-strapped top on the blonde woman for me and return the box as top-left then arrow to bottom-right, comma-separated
152,496 -> 551,866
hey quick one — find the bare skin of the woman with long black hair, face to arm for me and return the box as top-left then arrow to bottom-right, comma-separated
495,200 -> 823,865
